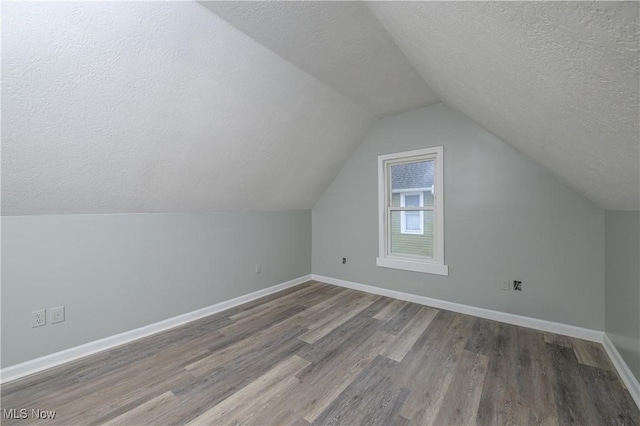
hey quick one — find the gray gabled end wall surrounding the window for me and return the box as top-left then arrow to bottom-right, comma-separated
312,104 -> 604,330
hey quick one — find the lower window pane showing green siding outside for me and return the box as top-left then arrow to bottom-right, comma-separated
389,211 -> 433,259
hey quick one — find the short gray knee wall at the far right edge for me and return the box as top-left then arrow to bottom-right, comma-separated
605,210 -> 640,380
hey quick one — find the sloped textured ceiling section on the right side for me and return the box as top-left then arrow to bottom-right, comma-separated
368,2 -> 640,210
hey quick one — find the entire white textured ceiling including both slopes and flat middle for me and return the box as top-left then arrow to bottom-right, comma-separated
2,2 -> 640,215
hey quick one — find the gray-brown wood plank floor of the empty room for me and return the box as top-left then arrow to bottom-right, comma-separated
1,281 -> 640,425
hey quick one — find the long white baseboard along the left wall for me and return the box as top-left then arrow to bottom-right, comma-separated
0,275 -> 312,383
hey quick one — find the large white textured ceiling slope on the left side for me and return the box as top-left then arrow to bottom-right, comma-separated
2,2 -> 374,215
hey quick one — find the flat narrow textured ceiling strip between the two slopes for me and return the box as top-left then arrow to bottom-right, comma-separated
202,1 -> 437,116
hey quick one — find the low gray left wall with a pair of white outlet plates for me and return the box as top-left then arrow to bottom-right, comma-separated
2,210 -> 311,367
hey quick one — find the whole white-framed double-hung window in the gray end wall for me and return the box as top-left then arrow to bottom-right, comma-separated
376,147 -> 449,275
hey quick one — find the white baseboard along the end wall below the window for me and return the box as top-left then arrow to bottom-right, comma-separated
311,274 -> 604,343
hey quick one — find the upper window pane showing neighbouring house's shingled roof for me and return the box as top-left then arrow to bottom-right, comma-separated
391,160 -> 435,207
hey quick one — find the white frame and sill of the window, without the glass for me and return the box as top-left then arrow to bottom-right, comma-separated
376,146 -> 449,275
